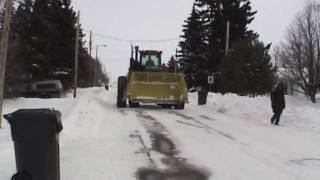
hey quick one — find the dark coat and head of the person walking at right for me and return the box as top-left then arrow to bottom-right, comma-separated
271,84 -> 286,113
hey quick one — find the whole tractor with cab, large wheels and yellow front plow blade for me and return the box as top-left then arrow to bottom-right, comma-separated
117,46 -> 188,109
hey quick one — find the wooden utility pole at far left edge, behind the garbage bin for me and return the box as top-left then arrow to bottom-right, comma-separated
0,0 -> 13,128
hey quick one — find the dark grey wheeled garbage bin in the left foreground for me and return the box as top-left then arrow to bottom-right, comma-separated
4,109 -> 62,180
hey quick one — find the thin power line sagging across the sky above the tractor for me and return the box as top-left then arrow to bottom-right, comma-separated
84,30 -> 180,43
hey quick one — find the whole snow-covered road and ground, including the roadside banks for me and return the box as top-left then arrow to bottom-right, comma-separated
0,88 -> 320,180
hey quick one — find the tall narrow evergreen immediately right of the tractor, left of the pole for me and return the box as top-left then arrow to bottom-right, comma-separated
179,5 -> 207,88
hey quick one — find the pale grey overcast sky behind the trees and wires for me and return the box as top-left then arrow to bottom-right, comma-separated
73,0 -> 305,80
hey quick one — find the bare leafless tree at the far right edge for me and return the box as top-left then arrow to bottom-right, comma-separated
278,0 -> 320,102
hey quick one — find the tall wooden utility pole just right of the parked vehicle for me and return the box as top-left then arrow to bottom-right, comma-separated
73,11 -> 80,98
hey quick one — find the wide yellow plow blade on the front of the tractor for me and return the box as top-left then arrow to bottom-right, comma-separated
126,72 -> 188,109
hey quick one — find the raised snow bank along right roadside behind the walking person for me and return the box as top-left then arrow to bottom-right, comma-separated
189,93 -> 320,131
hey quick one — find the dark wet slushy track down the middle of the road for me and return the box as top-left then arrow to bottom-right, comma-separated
136,109 -> 210,180
